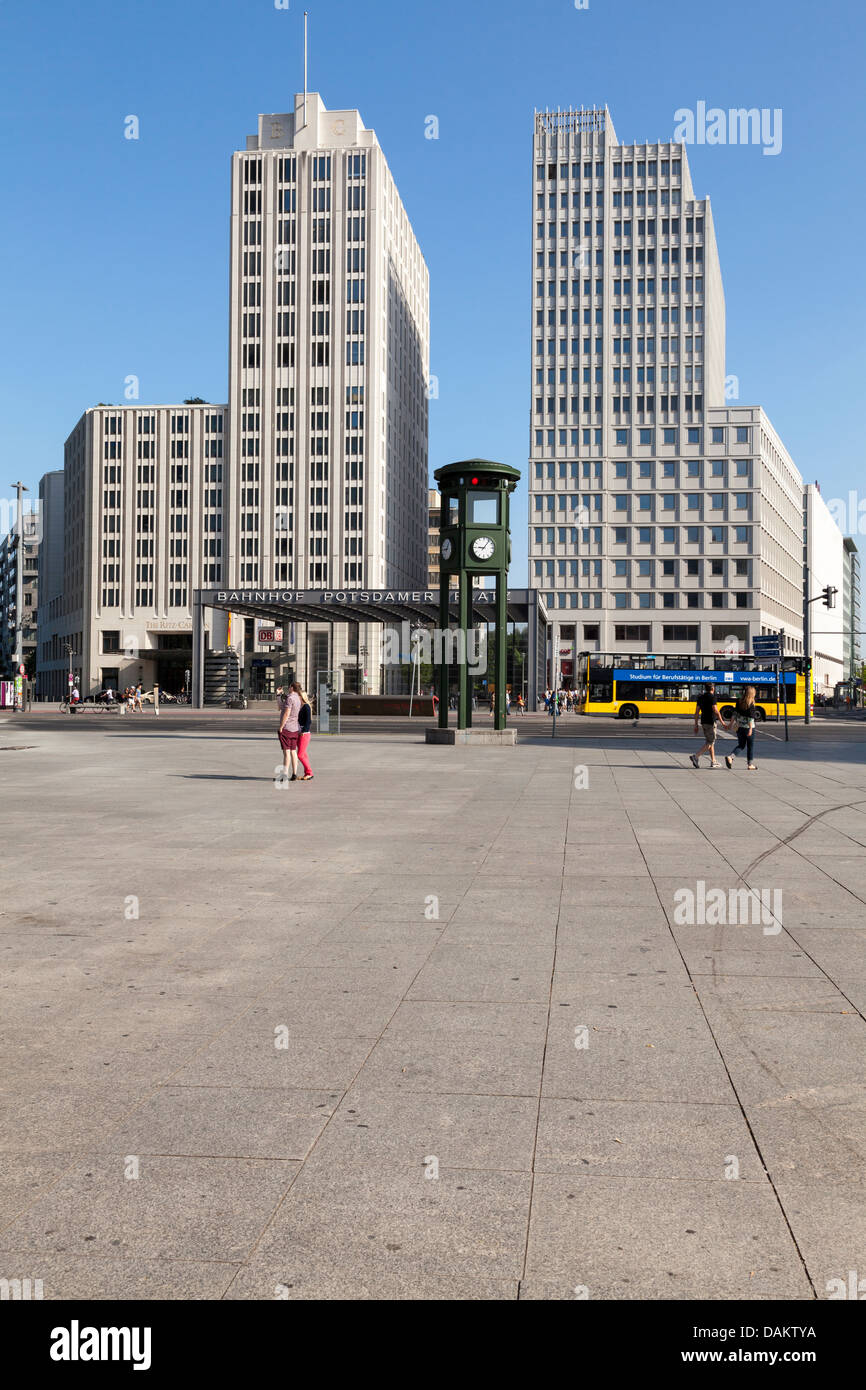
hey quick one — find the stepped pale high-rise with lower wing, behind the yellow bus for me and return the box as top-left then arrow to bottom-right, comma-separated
530,108 -> 802,672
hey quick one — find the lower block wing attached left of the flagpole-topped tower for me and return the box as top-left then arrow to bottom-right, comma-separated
39,404 -> 227,699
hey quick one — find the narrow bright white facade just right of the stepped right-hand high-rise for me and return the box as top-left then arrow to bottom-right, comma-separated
802,482 -> 848,699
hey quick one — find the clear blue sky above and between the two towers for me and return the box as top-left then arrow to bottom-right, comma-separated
0,0 -> 866,582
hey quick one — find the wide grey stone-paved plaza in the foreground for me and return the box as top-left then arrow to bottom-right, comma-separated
0,712 -> 866,1300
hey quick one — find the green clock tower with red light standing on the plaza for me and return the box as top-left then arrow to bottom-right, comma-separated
434,459 -> 520,731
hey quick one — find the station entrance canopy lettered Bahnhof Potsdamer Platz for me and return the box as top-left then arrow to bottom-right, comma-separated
193,588 -> 548,706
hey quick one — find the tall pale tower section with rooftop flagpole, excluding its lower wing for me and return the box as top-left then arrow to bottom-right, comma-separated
225,92 -> 430,686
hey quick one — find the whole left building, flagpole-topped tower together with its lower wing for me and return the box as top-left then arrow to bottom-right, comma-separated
40,93 -> 430,698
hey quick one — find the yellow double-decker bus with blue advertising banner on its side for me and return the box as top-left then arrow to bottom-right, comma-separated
577,652 -> 812,720
